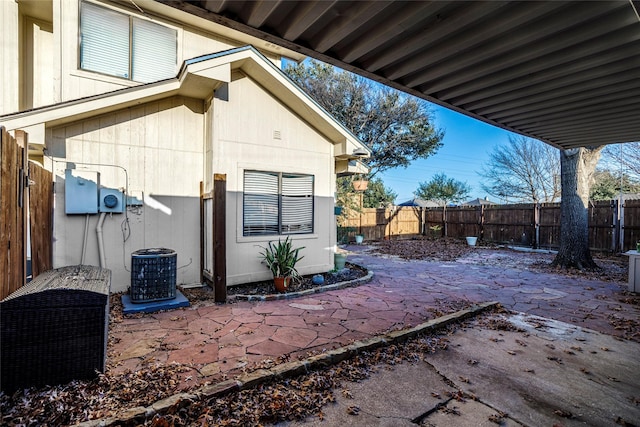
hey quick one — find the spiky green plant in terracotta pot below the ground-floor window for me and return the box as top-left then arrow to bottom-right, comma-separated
260,236 -> 304,293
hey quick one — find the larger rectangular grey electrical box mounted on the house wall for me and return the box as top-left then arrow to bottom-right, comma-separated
64,169 -> 100,214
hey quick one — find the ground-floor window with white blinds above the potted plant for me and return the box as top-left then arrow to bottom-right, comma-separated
243,170 -> 314,236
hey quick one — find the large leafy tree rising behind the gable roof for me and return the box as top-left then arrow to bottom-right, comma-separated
284,60 -> 444,178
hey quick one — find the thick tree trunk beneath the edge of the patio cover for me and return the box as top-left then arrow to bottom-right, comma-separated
553,147 -> 603,269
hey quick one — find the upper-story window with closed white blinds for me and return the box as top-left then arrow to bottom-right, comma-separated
80,2 -> 178,83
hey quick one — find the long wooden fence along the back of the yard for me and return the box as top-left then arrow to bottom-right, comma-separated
338,200 -> 640,252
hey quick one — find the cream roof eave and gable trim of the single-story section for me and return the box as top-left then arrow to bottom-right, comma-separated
0,46 -> 371,159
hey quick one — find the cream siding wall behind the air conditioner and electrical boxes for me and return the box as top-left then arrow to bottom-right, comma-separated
46,97 -> 204,292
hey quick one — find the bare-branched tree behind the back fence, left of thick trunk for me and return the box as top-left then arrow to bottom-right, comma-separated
479,136 -> 560,203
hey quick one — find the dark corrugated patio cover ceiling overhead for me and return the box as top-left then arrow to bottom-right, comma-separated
168,0 -> 640,148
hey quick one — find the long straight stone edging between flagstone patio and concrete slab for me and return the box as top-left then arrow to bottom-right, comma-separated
76,300 -> 499,427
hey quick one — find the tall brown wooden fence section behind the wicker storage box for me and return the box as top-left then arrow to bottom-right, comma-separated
0,127 -> 53,300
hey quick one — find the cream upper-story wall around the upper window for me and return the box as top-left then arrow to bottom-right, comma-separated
0,0 -> 280,117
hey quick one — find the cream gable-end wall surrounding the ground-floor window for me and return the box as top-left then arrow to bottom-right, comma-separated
205,74 -> 336,285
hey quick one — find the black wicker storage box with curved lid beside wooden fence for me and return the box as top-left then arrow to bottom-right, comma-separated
0,265 -> 111,393
